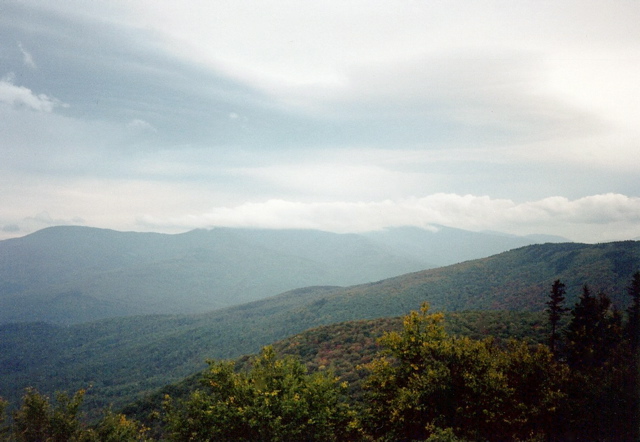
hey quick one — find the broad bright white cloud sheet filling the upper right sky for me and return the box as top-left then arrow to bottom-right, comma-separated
112,0 -> 640,167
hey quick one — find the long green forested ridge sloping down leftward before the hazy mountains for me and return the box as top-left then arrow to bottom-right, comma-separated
0,241 -> 640,407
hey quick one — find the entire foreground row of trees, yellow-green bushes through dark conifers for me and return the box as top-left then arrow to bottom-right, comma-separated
0,272 -> 640,441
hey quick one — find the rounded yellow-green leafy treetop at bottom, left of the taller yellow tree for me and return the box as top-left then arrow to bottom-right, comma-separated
165,347 -> 353,441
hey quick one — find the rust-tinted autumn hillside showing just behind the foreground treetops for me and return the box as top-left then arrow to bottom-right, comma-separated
124,311 -> 547,427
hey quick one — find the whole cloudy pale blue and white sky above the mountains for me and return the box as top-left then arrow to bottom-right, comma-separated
0,0 -> 640,243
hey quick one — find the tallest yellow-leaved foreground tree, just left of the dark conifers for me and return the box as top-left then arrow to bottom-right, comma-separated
365,304 -> 564,440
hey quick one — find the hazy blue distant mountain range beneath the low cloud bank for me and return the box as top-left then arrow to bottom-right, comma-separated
0,226 -> 560,323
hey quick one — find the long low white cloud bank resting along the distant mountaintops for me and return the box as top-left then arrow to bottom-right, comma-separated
139,193 -> 640,241
